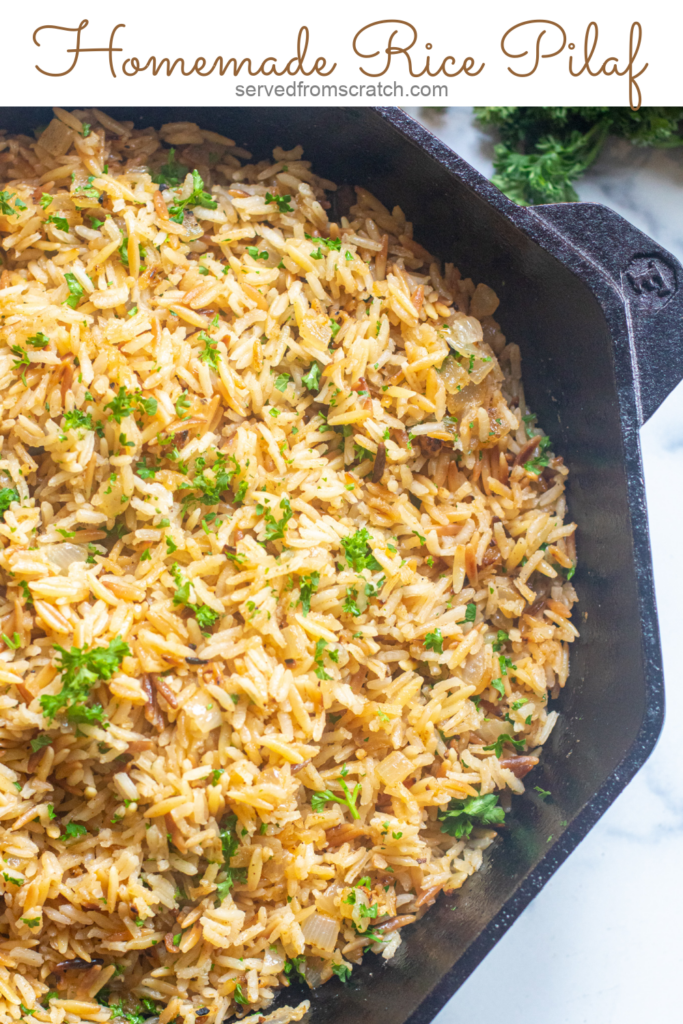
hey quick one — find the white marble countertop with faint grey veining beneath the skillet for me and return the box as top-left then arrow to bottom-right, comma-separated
407,108 -> 683,1024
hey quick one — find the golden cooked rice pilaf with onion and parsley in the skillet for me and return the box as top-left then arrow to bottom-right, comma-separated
0,110 -> 578,1024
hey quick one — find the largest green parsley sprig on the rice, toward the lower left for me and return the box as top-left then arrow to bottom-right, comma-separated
40,636 -> 130,723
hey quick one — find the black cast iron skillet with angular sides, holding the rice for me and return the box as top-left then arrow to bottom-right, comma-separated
0,105 -> 683,1024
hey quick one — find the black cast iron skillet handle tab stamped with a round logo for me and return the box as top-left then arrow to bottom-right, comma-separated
525,203 -> 683,425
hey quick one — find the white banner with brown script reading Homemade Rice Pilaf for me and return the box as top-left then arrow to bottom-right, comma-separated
0,0 -> 683,108
